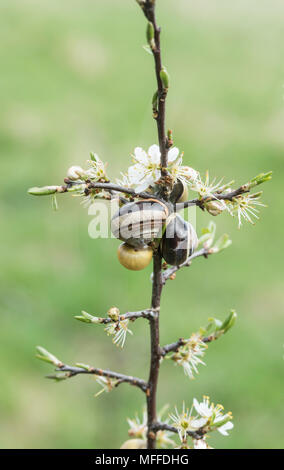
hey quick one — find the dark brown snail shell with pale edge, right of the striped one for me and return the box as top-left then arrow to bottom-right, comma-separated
161,213 -> 198,266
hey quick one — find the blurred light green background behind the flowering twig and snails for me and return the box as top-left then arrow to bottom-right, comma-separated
0,0 -> 284,448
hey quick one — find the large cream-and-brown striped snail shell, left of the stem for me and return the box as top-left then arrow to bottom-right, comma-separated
111,199 -> 169,248
